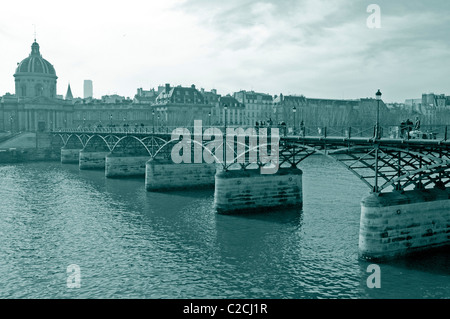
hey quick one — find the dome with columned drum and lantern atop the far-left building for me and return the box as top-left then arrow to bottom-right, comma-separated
14,40 -> 58,98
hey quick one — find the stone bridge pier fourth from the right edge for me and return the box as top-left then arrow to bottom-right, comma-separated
105,154 -> 150,177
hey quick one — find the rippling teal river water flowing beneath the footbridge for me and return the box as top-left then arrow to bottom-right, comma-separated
0,156 -> 450,299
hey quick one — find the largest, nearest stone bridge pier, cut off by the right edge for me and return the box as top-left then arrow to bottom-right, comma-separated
359,188 -> 450,260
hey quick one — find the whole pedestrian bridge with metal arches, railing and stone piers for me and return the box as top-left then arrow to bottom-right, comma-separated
46,127 -> 450,259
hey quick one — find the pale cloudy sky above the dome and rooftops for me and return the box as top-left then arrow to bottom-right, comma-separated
0,0 -> 450,102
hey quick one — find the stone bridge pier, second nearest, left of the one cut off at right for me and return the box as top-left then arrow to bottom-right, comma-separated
214,168 -> 303,214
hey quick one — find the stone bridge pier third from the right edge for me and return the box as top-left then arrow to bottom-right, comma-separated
145,160 -> 216,191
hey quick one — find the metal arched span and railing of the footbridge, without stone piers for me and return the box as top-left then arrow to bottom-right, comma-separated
51,128 -> 450,193
